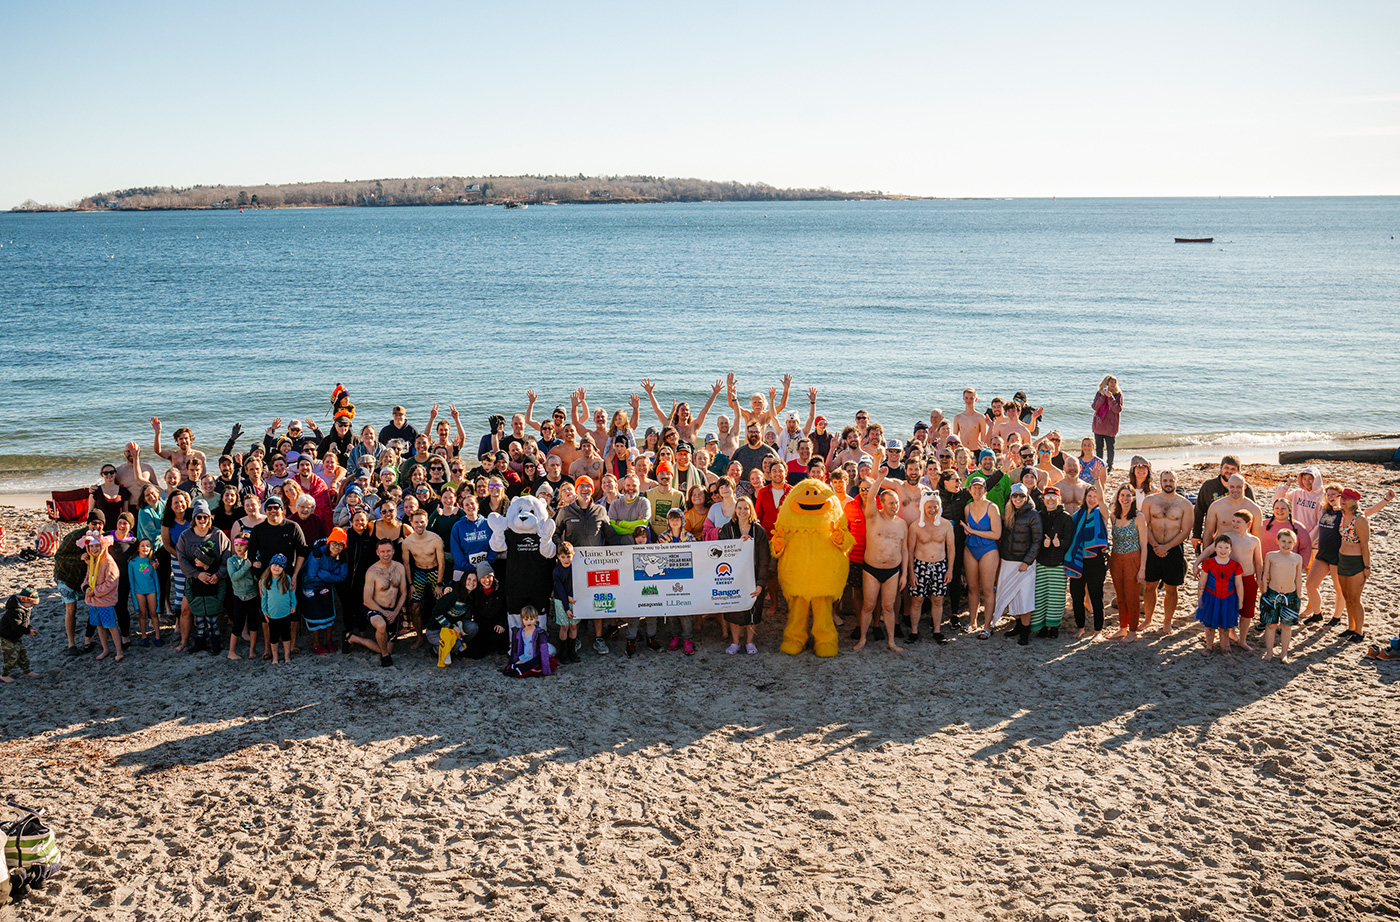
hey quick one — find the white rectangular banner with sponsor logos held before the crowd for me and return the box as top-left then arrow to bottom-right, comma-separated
574,540 -> 753,618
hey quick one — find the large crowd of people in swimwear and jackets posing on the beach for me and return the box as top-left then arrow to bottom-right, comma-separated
0,375 -> 1393,680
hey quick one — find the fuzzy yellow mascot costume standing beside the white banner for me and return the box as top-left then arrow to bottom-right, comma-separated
769,478 -> 855,656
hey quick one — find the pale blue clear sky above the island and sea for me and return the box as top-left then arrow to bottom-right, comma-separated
0,1 -> 1400,208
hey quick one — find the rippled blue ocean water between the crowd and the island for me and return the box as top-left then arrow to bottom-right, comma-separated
0,197 -> 1400,492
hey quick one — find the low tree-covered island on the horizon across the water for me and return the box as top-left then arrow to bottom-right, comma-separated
13,173 -> 910,211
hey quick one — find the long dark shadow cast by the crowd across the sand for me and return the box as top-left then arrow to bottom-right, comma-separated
0,601 -> 1360,774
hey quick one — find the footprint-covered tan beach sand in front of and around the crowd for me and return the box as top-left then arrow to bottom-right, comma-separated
0,464 -> 1400,922
